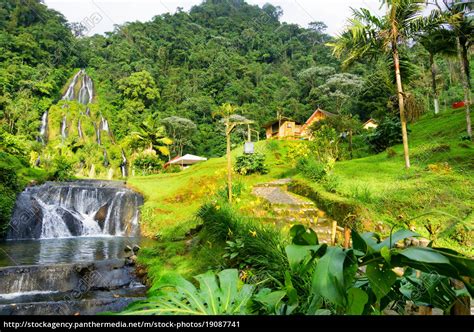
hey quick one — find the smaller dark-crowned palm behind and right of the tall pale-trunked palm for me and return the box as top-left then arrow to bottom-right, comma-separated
419,28 -> 457,114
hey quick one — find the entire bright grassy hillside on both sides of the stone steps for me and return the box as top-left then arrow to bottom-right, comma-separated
129,110 -> 474,256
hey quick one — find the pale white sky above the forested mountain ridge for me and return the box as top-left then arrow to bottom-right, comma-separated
45,0 -> 386,35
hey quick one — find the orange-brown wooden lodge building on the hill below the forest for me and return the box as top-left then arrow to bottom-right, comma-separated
263,108 -> 336,139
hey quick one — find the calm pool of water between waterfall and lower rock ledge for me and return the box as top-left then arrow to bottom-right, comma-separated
0,236 -> 150,266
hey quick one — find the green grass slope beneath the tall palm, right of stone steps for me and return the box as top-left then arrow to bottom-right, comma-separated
300,110 -> 474,256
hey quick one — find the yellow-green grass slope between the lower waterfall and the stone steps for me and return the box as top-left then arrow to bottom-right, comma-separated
128,141 -> 294,237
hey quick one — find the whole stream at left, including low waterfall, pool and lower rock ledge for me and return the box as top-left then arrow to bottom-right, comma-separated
0,180 -> 146,315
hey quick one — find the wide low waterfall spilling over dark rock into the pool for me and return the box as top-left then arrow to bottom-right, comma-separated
8,180 -> 143,239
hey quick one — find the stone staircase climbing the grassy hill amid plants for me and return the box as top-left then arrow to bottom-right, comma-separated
252,179 -> 332,243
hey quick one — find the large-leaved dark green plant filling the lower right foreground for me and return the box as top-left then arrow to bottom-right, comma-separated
256,225 -> 474,315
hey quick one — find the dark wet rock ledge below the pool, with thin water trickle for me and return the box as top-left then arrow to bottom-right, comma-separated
0,259 -> 146,315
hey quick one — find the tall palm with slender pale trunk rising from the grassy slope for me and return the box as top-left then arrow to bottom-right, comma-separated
329,0 -> 425,168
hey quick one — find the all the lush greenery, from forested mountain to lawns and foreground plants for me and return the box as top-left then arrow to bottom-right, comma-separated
0,0 -> 474,314
